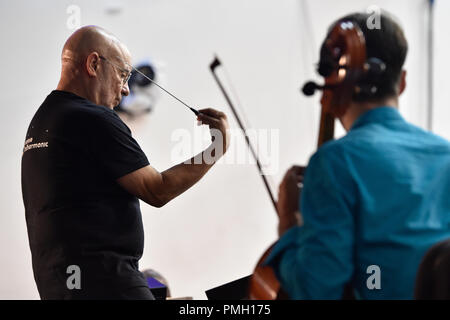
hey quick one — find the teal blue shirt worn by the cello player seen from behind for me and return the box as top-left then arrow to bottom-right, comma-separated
266,107 -> 450,299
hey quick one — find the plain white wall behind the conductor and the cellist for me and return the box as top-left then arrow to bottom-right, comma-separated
0,0 -> 450,299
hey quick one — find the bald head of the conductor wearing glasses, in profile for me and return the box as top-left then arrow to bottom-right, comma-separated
58,26 -> 131,108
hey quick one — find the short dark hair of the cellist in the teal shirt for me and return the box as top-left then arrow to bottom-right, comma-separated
333,11 -> 408,102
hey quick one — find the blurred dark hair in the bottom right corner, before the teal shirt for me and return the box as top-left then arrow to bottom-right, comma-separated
414,239 -> 450,300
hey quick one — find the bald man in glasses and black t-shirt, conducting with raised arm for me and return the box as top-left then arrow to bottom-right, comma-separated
22,26 -> 229,299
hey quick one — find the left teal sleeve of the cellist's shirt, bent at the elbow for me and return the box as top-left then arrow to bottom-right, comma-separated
266,146 -> 354,299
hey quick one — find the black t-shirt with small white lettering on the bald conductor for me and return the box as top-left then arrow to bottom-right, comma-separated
22,90 -> 149,299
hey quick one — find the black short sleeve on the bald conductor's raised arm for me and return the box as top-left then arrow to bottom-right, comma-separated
89,110 -> 149,180
